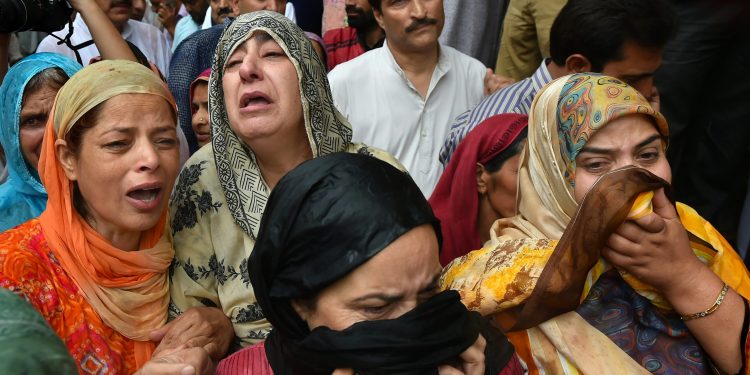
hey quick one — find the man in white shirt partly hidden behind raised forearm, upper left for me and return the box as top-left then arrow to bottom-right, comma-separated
36,0 -> 170,76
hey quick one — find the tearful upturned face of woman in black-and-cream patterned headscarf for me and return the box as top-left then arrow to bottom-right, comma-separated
223,32 -> 305,147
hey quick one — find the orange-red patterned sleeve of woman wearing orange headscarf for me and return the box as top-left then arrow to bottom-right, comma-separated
0,219 -> 137,375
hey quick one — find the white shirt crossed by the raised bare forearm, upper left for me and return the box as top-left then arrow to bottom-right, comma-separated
36,14 -> 171,76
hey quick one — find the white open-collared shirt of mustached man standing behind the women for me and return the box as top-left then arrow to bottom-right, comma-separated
328,41 -> 487,197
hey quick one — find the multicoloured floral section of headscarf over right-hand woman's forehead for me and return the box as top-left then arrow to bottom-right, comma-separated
557,74 -> 669,186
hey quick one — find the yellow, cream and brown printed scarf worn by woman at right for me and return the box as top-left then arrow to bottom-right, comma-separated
441,74 -> 750,374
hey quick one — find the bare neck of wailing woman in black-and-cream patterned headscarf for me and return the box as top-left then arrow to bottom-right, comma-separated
250,134 -> 313,190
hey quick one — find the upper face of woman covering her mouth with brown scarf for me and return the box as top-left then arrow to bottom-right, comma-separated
574,115 -> 672,202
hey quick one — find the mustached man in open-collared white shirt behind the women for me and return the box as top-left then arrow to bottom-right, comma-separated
328,0 -> 487,197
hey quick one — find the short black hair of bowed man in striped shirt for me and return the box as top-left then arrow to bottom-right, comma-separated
550,0 -> 677,72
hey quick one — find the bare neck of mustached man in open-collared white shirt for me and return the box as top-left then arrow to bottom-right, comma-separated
388,42 -> 440,98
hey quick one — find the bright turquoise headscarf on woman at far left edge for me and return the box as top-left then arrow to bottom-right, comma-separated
0,53 -> 81,231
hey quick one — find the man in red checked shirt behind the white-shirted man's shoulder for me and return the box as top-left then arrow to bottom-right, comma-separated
323,0 -> 385,70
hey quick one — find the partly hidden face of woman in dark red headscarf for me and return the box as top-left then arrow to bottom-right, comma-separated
480,153 -> 521,218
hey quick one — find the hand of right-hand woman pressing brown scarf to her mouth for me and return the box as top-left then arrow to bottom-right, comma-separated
602,189 -> 708,298
